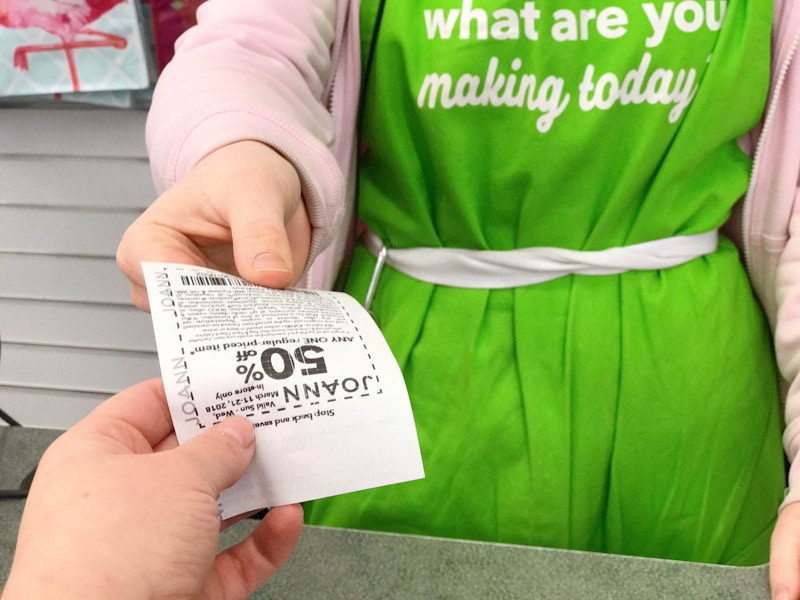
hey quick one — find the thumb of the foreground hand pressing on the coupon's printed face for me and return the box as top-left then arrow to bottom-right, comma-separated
174,416 -> 255,496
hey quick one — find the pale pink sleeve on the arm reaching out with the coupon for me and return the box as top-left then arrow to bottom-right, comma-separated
147,0 -> 345,270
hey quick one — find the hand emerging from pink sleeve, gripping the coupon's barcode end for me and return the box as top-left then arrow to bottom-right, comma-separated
117,141 -> 311,310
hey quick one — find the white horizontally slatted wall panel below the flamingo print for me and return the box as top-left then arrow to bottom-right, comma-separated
0,107 -> 159,429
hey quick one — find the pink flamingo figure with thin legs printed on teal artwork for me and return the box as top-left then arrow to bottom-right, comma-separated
0,0 -> 128,92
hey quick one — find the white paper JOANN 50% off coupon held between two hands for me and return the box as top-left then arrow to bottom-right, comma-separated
142,263 -> 424,518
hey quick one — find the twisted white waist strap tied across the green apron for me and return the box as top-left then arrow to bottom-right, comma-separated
365,230 -> 719,289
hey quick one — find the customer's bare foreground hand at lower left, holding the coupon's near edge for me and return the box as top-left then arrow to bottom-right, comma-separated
3,379 -> 303,600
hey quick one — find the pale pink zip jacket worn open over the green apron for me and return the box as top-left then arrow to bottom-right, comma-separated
147,0 -> 800,502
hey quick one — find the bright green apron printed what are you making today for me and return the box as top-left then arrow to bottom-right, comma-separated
307,0 -> 784,564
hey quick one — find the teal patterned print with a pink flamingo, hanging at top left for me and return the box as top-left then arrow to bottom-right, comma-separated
0,0 -> 150,96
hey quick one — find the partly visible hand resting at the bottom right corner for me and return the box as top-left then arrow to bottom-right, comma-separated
769,502 -> 800,600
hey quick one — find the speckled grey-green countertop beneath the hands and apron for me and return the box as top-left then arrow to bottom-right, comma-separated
0,427 -> 769,600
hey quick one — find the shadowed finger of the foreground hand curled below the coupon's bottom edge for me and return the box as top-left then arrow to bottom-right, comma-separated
206,504 -> 303,598
